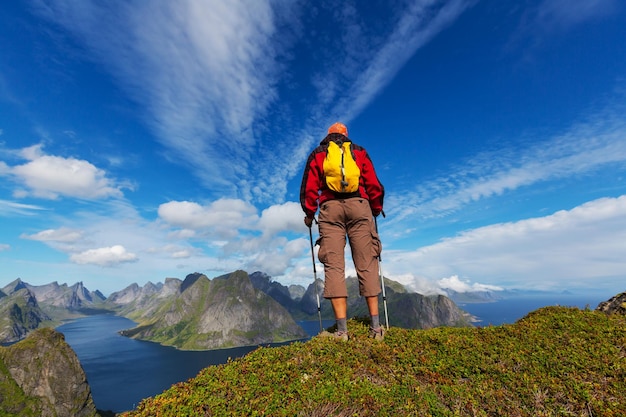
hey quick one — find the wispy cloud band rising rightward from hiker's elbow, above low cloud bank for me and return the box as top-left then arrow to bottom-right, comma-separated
387,98 -> 626,228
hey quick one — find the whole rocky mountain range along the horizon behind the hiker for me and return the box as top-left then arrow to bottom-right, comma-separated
0,271 -> 471,350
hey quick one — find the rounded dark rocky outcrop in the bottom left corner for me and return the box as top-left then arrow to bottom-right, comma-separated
0,329 -> 97,417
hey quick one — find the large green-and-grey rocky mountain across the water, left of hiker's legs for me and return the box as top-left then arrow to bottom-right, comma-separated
122,271 -> 306,350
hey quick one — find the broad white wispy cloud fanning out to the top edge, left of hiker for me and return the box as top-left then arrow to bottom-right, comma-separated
31,0 -> 289,196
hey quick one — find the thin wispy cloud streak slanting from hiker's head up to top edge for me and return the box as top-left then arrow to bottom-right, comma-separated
256,0 -> 475,203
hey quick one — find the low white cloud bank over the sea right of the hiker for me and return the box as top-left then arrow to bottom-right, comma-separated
386,195 -> 626,289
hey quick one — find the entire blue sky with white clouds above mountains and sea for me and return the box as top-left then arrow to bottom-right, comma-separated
0,0 -> 626,297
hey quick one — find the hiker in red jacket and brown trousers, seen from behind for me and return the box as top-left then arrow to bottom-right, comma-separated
300,123 -> 385,340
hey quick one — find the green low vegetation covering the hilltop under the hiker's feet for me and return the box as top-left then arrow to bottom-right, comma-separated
124,307 -> 626,417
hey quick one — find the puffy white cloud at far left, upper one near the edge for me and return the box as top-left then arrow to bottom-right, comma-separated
3,145 -> 122,199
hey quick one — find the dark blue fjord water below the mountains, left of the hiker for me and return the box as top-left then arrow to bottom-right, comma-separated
57,314 -> 332,412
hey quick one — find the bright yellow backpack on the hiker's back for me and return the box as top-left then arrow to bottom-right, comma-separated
324,141 -> 361,193
